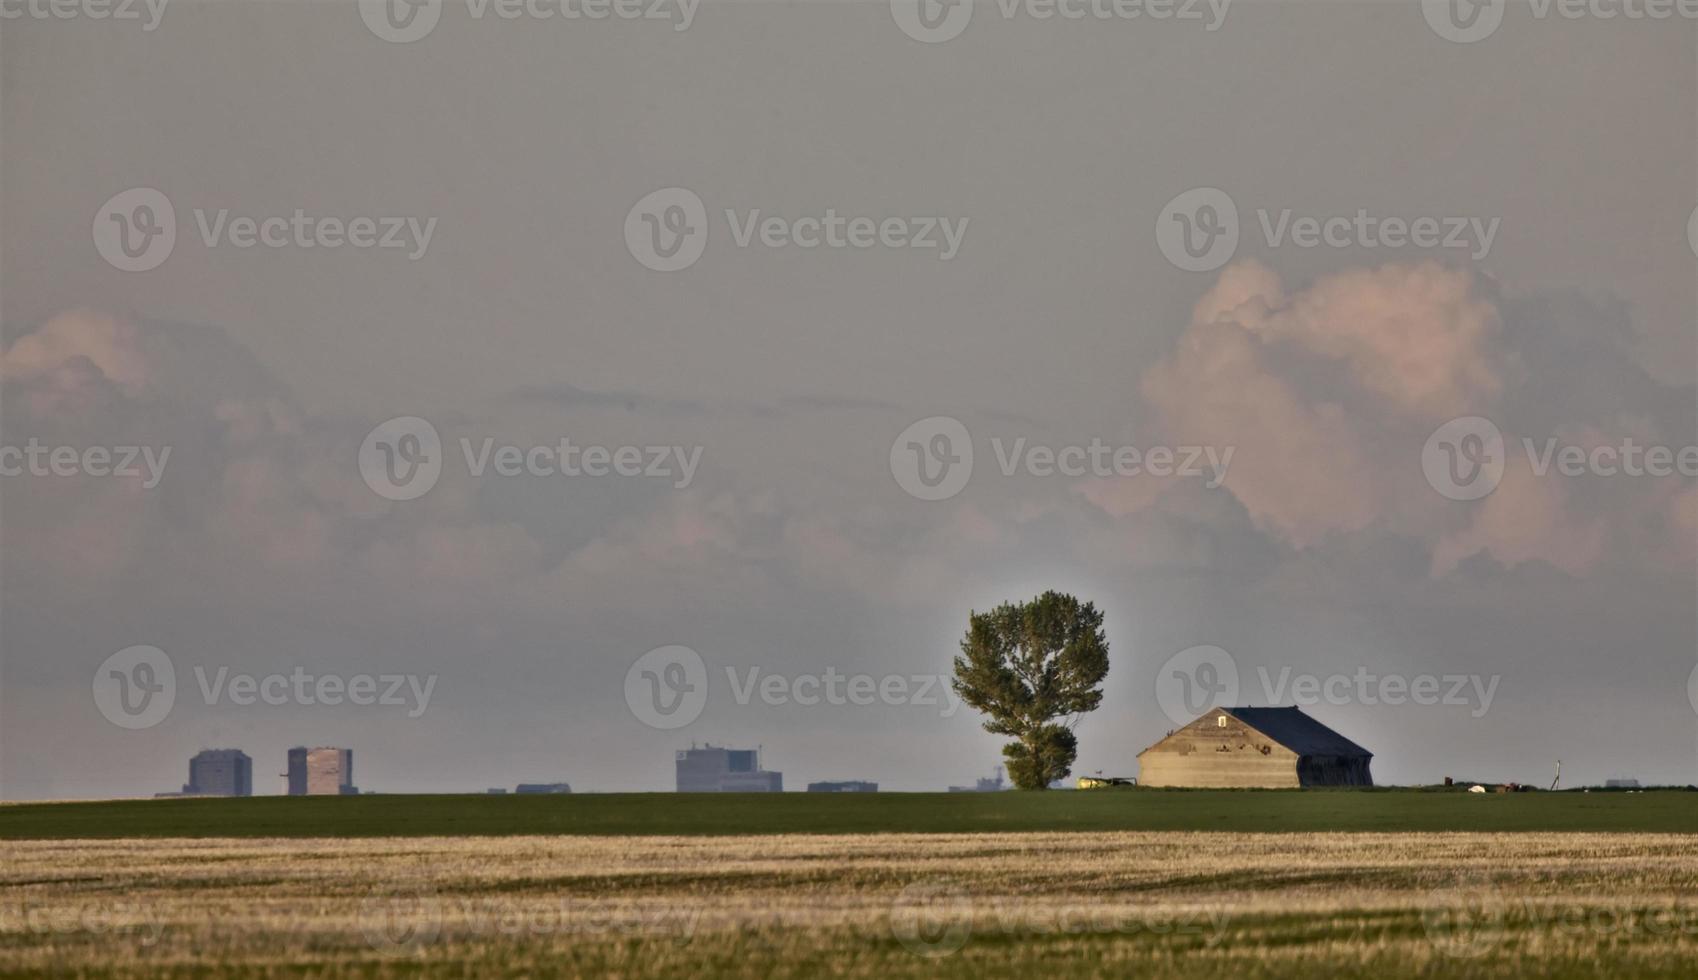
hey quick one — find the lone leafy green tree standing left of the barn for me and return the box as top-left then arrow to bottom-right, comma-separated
951,591 -> 1109,790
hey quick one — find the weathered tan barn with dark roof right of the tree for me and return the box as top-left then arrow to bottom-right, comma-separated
1138,708 -> 1374,790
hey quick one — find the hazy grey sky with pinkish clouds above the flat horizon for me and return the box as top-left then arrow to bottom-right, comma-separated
0,0 -> 1698,800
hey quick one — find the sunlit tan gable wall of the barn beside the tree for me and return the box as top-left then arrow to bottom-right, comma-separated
1138,713 -> 1302,790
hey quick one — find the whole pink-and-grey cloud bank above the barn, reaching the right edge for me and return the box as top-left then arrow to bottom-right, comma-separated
1082,262 -> 1693,574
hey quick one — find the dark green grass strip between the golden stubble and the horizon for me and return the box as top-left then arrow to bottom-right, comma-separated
0,790 -> 1698,841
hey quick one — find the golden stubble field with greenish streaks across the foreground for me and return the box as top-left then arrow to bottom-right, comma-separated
0,832 -> 1698,978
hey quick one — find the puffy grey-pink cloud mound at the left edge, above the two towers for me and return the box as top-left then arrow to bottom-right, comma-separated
0,311 -> 523,594
